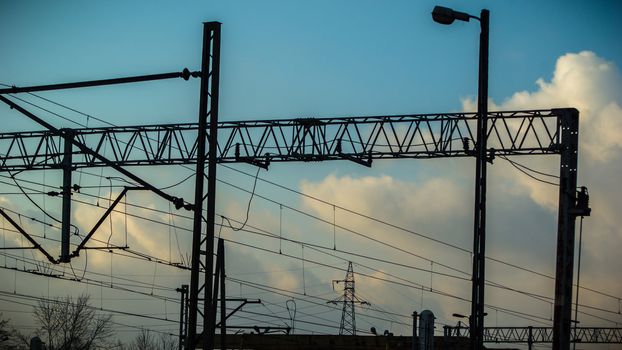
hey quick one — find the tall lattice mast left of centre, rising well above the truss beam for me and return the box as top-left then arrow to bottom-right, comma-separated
186,22 -> 220,349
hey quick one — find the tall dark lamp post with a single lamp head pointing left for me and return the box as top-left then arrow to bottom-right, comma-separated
432,6 -> 490,349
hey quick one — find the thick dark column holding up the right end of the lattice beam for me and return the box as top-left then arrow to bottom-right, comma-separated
553,108 -> 579,350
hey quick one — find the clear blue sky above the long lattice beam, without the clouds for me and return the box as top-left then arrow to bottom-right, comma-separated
0,1 -> 622,121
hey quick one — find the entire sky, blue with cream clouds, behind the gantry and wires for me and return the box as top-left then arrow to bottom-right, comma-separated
0,0 -> 622,348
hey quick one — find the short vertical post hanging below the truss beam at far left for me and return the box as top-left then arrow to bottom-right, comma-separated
59,129 -> 73,262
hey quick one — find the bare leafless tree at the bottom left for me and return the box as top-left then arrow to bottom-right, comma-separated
35,295 -> 113,350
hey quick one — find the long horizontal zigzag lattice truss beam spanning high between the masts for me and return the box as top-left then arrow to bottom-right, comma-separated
0,110 -> 562,171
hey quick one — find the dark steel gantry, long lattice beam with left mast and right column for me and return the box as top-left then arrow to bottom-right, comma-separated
0,22 -> 585,349
